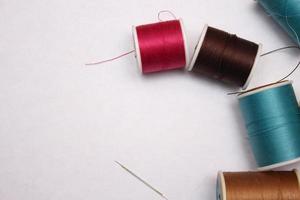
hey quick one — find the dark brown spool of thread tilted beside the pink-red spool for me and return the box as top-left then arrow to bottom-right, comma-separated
188,25 -> 261,89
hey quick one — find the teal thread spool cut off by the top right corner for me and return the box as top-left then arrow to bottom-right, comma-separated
257,0 -> 300,45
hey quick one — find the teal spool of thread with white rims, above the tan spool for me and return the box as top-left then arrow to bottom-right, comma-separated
239,81 -> 300,170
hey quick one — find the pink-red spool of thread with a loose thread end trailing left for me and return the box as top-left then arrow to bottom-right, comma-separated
133,19 -> 188,73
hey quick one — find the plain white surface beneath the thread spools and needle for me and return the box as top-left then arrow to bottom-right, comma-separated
0,0 -> 300,200
